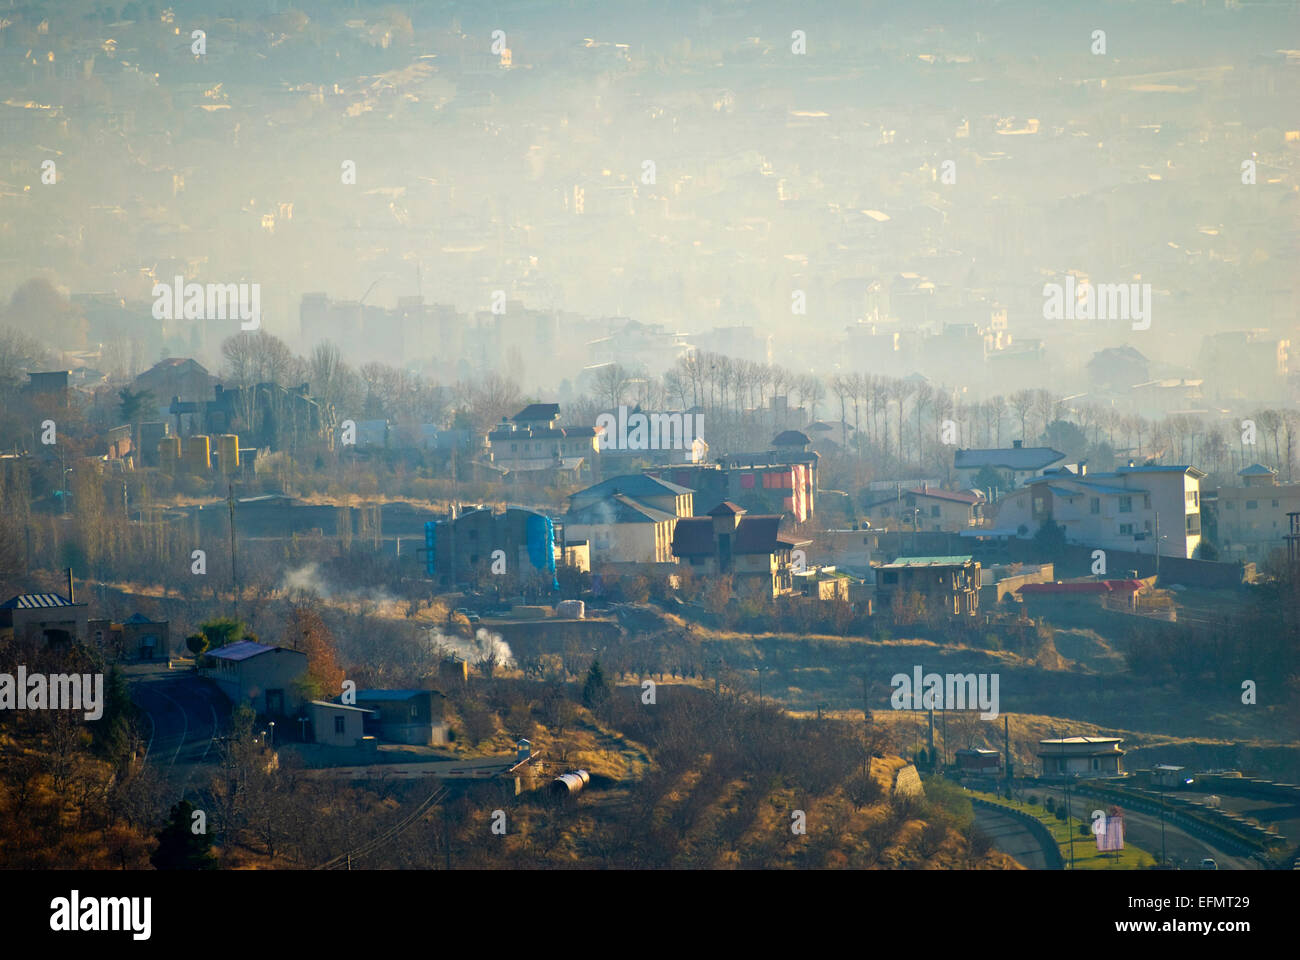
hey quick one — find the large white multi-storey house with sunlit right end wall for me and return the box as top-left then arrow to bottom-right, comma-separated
992,466 -> 1205,557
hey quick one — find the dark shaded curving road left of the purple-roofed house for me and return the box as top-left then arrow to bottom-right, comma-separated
127,667 -> 230,796
